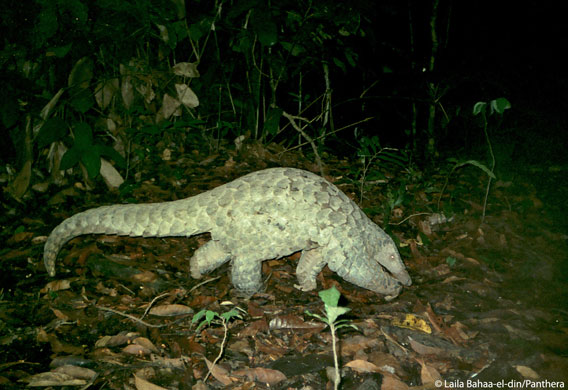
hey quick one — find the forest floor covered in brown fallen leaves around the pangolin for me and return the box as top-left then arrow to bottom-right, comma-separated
0,145 -> 568,390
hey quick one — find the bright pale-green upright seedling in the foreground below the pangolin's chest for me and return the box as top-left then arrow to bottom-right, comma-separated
306,286 -> 357,390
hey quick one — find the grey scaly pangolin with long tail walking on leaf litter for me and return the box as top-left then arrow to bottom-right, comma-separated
44,168 -> 411,298
